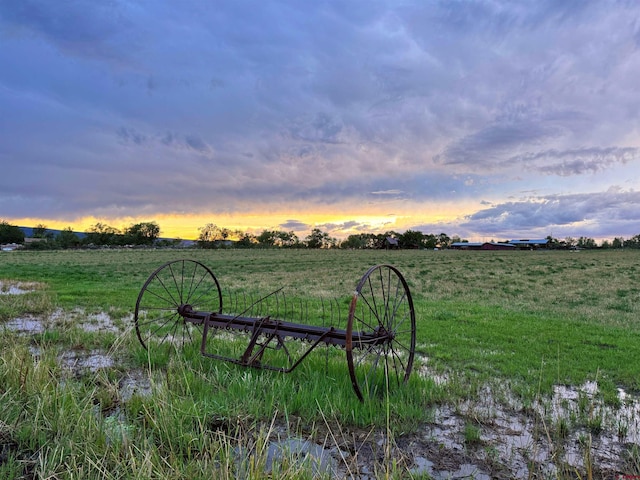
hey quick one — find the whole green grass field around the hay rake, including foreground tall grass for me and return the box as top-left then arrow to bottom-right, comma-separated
0,250 -> 640,478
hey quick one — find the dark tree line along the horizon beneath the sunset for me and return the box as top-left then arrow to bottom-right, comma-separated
0,221 -> 640,250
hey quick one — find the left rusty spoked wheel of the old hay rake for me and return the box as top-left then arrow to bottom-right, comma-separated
134,260 -> 222,351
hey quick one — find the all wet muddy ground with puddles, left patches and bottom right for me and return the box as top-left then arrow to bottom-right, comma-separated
0,306 -> 640,479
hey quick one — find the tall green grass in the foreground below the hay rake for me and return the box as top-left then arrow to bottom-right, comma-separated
0,337 -> 436,479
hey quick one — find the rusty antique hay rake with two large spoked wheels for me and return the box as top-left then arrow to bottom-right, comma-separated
134,260 -> 416,401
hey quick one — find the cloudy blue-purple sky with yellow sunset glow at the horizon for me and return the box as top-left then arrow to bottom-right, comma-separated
0,0 -> 640,241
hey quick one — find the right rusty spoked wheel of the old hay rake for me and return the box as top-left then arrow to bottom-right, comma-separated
346,265 -> 416,401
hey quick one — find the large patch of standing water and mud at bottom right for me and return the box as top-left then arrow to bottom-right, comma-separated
407,382 -> 640,479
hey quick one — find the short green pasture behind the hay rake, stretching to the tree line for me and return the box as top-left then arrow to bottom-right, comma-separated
0,250 -> 640,390
